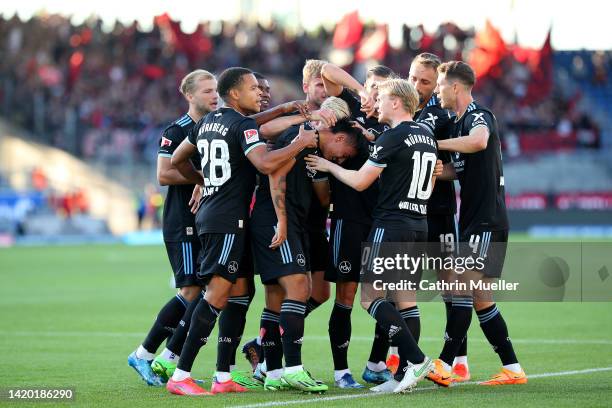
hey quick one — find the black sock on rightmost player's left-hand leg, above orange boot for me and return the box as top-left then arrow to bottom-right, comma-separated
440,296 -> 474,366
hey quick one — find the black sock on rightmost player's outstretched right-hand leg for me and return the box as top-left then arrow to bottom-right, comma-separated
476,305 -> 518,365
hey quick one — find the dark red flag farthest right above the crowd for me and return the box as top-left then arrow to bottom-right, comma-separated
524,29 -> 553,104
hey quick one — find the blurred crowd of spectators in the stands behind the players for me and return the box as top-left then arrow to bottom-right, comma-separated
0,15 -> 610,163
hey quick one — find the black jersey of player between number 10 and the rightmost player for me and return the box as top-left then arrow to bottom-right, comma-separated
414,94 -> 457,215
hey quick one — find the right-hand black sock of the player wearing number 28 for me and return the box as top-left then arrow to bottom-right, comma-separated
217,296 -> 249,372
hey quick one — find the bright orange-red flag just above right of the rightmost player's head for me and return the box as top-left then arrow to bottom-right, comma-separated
469,20 -> 508,78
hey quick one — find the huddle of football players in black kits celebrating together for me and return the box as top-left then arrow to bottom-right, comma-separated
128,53 -> 527,395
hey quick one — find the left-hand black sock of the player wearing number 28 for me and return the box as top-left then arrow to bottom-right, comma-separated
176,299 -> 221,371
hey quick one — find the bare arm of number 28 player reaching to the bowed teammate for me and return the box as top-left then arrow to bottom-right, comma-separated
247,126 -> 319,175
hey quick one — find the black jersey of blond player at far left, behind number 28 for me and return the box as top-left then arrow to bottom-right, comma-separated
157,114 -> 200,242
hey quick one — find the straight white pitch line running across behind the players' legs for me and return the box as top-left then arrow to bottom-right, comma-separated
0,331 -> 612,345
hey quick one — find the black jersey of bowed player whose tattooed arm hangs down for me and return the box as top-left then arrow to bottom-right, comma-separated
252,125 -> 327,229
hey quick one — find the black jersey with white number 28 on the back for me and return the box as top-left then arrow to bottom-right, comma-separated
188,108 -> 265,234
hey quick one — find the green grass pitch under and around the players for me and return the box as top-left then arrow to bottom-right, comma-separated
0,241 -> 612,407
